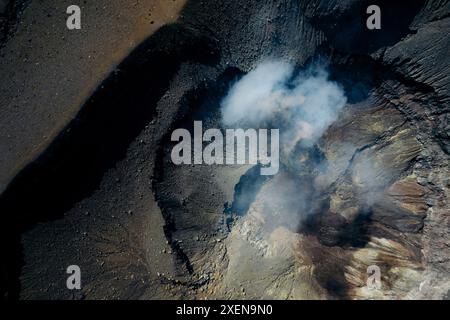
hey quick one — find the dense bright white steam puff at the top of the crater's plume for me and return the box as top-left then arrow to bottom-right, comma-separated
221,61 -> 347,155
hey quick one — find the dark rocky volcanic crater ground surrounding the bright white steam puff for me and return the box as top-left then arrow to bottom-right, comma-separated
0,0 -> 450,299
